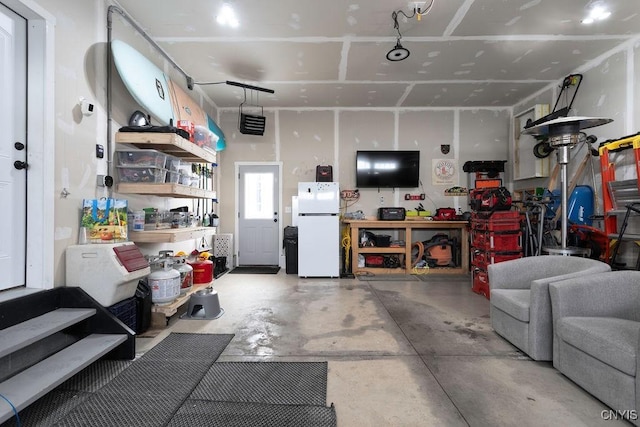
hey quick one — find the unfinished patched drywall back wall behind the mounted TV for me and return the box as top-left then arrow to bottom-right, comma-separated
219,108 -> 511,233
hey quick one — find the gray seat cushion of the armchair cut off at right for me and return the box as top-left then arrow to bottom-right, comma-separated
556,317 -> 640,376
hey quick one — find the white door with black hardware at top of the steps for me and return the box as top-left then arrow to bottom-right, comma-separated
0,4 -> 28,290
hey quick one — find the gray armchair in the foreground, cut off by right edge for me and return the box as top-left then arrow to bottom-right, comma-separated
549,271 -> 640,425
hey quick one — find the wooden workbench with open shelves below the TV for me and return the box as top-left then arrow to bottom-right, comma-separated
343,219 -> 469,274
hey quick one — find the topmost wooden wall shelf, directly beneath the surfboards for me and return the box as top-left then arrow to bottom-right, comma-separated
116,132 -> 216,163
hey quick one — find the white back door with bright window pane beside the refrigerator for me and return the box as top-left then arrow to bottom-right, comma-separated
238,164 -> 280,265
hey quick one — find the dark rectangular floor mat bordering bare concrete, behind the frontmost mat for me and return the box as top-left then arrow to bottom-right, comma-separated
190,362 -> 327,406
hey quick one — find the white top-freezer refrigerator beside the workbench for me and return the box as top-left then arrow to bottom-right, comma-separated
298,182 -> 340,277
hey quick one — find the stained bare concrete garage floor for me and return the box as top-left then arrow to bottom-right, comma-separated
137,270 -> 626,427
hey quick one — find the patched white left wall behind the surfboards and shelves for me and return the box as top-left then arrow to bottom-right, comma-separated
29,0 -> 216,286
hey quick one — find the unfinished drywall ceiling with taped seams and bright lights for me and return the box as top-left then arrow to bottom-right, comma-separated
114,0 -> 640,108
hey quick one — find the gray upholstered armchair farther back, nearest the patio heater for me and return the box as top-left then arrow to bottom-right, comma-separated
487,255 -> 611,360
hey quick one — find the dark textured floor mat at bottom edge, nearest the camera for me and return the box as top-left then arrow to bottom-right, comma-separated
168,400 -> 337,427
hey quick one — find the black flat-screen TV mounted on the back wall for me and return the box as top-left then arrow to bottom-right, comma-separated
356,150 -> 420,188
